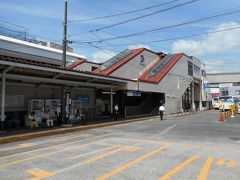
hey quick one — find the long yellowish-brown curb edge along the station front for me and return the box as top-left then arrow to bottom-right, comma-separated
0,116 -> 158,144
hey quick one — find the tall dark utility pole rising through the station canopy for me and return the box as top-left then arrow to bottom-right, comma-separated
61,0 -> 68,124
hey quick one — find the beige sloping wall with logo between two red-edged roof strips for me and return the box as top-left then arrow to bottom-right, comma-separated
111,50 -> 159,79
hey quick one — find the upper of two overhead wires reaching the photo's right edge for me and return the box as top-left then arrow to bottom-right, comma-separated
76,9 -> 240,43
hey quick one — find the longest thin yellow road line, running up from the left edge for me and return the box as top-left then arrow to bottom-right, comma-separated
0,139 -> 106,167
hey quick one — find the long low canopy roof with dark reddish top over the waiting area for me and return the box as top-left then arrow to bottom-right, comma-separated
0,55 -> 127,87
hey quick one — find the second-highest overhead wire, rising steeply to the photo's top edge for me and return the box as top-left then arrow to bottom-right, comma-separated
90,0 -> 199,32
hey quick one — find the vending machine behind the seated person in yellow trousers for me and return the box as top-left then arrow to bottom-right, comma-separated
28,99 -> 44,122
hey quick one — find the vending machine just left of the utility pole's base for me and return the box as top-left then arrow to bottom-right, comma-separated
45,99 -> 61,120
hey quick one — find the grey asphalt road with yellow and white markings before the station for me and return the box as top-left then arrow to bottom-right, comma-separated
0,111 -> 240,180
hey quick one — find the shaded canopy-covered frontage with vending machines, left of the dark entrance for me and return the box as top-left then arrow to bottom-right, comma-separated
0,56 -> 126,128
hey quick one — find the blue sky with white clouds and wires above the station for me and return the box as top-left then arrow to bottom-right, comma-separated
0,0 -> 240,72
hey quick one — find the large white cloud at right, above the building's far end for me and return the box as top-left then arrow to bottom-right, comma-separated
172,22 -> 240,56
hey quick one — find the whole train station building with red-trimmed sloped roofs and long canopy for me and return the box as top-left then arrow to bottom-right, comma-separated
0,33 -> 207,127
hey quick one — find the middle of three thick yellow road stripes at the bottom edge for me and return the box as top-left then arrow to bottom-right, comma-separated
159,156 -> 199,180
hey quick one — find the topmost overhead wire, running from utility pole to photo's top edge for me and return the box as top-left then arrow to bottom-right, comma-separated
68,0 -> 180,23
